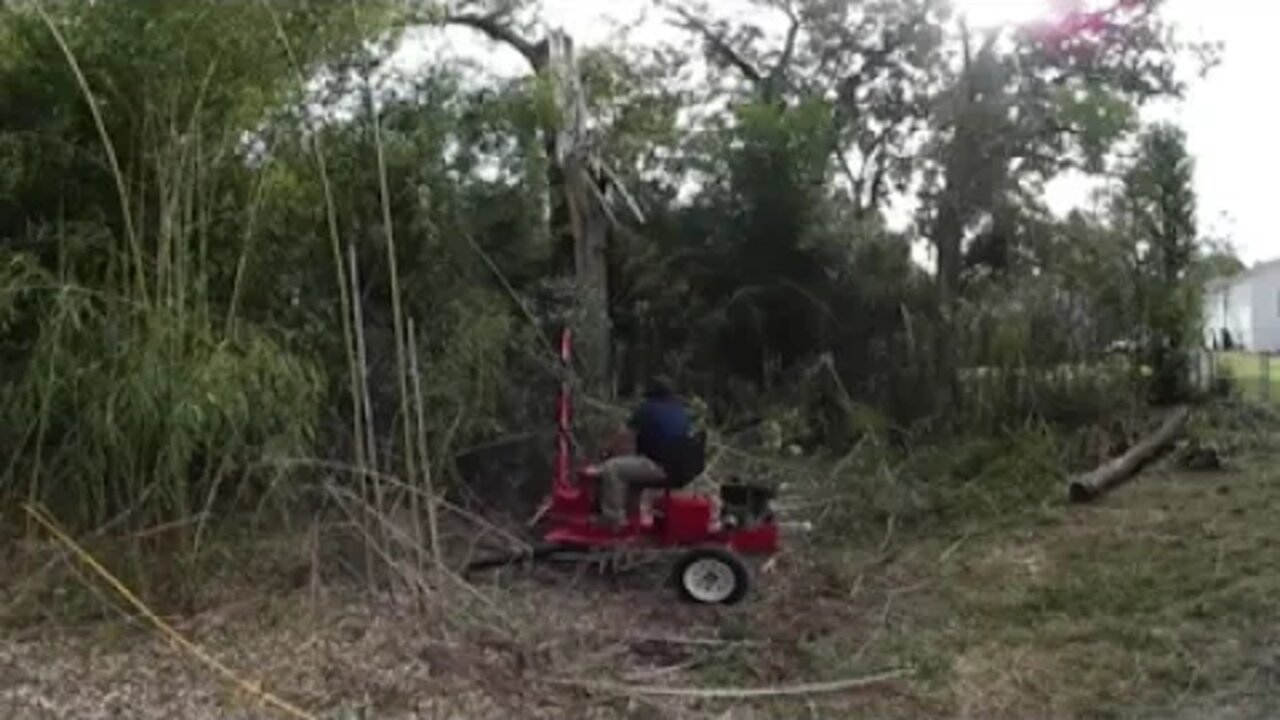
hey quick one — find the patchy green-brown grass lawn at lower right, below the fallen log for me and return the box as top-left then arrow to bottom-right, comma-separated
703,404 -> 1280,720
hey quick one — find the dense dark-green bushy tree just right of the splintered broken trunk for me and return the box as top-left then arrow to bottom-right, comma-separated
622,96 -> 870,397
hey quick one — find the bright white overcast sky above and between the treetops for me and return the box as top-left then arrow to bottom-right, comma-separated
419,0 -> 1280,263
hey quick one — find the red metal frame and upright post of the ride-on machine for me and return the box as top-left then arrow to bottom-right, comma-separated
544,329 -> 778,555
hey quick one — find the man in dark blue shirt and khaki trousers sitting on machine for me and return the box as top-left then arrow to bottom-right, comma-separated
599,379 -> 705,528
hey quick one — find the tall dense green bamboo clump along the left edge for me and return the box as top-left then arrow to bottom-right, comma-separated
0,3 -> 378,528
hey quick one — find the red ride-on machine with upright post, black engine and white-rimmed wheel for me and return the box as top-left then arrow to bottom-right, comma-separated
472,331 -> 780,605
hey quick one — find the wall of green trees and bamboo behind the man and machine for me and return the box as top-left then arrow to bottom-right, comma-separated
0,0 -> 1208,543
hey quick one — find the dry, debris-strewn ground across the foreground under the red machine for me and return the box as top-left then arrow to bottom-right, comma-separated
0,440 -> 1280,720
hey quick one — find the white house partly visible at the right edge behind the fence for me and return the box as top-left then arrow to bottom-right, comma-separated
1204,260 -> 1280,352
